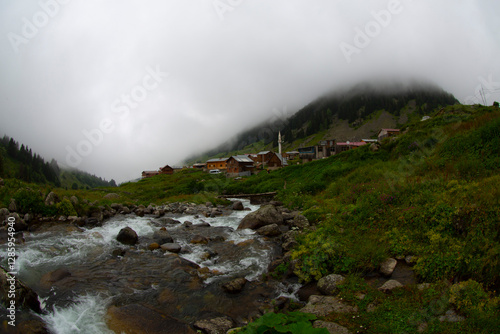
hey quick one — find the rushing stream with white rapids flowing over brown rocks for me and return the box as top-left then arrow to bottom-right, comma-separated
0,201 -> 290,334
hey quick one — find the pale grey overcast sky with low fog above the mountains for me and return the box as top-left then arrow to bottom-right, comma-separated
0,0 -> 500,182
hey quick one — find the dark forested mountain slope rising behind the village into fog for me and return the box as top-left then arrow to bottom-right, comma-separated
190,82 -> 458,161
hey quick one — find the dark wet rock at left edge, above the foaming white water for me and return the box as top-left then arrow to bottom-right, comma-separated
0,267 -> 42,313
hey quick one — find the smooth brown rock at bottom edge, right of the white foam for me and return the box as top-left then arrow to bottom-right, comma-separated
105,304 -> 196,334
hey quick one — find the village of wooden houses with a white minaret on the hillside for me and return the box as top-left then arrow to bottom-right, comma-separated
142,129 -> 400,178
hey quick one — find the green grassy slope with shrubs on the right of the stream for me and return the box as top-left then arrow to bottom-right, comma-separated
227,106 -> 500,333
